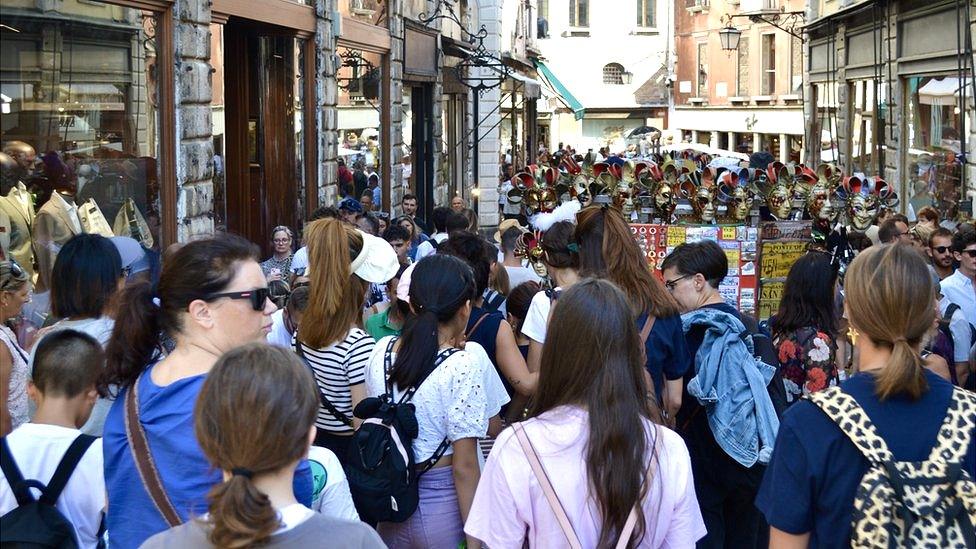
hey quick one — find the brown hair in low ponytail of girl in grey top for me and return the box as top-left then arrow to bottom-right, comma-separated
193,343 -> 319,548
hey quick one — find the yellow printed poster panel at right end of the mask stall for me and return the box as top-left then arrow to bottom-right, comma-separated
759,221 -> 812,320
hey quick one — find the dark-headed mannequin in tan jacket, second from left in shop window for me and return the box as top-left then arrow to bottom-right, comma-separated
34,152 -> 84,289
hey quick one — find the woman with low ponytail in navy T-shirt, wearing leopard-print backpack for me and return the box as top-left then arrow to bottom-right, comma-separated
756,244 -> 976,547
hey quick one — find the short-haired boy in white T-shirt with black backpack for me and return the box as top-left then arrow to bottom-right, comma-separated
0,330 -> 106,547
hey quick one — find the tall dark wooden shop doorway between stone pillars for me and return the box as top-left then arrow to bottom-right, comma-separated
223,17 -> 304,254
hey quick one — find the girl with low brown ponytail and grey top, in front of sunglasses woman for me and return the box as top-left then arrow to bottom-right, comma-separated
143,343 -> 383,549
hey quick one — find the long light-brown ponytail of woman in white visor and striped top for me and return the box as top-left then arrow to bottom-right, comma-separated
299,219 -> 369,349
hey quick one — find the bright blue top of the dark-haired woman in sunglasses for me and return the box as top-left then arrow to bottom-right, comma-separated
102,366 -> 312,548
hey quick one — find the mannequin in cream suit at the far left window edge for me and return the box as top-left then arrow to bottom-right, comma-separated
0,148 -> 37,285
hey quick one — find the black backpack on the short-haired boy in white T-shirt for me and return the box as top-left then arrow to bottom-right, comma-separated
0,435 -> 96,549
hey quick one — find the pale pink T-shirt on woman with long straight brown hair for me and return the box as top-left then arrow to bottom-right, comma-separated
464,406 -> 705,549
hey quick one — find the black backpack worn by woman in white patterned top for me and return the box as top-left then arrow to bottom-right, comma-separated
344,338 -> 457,524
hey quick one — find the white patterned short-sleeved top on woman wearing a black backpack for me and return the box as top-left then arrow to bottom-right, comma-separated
366,336 -> 508,462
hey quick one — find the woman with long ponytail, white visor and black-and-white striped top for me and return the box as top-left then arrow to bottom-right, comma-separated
295,219 -> 400,460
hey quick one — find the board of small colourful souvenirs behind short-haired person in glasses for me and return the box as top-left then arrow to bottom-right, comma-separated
630,224 -> 759,314
